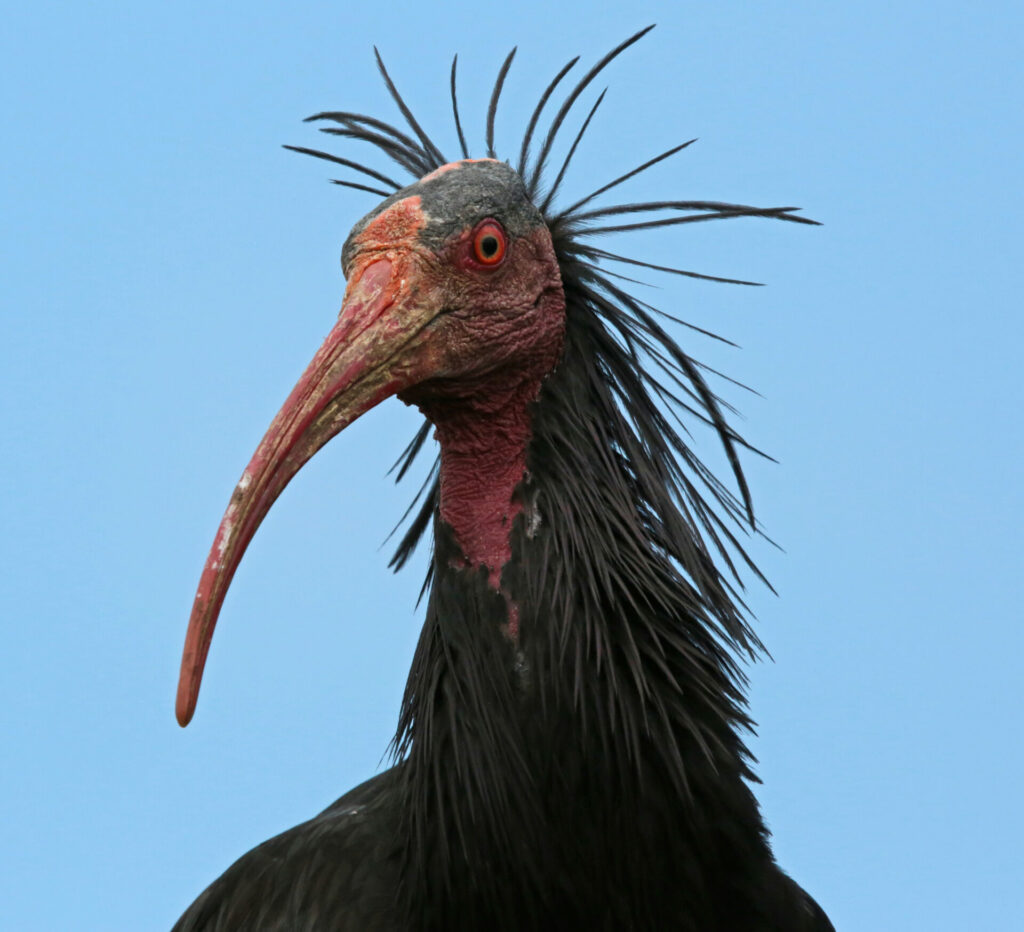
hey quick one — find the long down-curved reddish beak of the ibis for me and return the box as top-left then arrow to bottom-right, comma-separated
175,256 -> 441,727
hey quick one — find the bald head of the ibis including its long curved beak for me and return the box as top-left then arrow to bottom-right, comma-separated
176,159 -> 565,724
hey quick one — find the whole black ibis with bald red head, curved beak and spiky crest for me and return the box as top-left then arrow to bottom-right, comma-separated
174,27 -> 833,932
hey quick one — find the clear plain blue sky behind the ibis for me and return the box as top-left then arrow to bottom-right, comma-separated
0,0 -> 1024,932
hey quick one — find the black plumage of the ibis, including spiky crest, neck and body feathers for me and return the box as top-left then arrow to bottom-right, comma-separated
175,30 -> 831,932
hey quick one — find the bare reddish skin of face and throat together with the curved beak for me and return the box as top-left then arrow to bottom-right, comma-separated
176,175 -> 565,725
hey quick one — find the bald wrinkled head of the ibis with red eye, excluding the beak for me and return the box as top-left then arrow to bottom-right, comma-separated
338,159 -> 565,397
